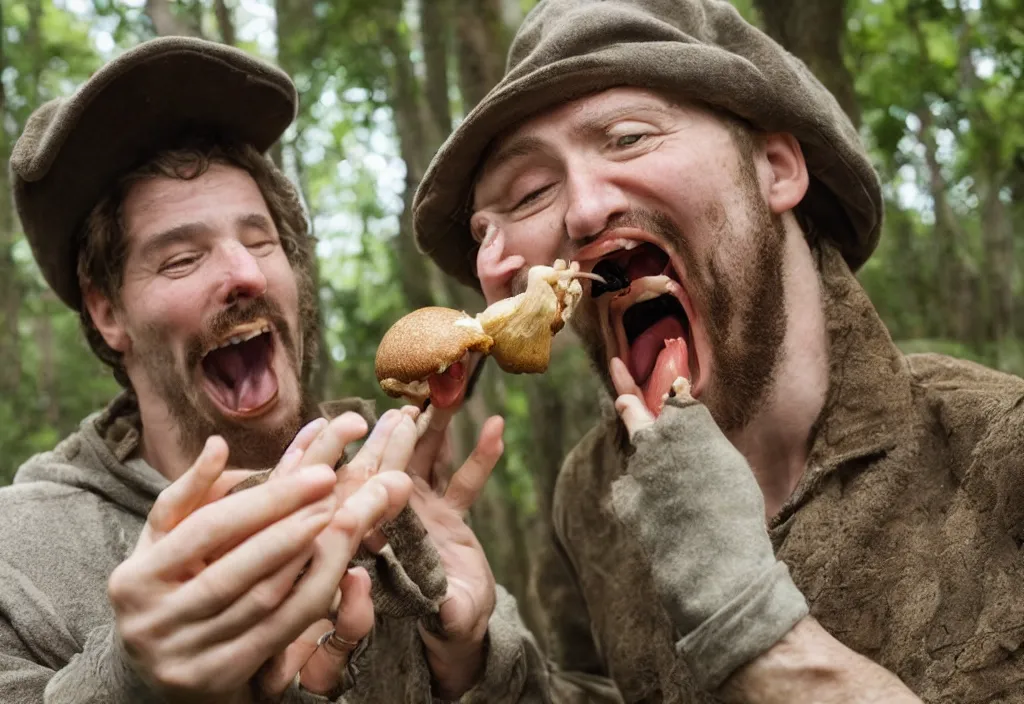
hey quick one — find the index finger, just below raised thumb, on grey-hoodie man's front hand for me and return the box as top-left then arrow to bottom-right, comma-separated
140,465 -> 336,576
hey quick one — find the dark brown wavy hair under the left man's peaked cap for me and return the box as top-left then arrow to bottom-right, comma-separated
78,139 -> 319,389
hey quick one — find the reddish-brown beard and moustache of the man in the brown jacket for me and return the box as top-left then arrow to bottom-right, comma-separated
572,170 -> 786,432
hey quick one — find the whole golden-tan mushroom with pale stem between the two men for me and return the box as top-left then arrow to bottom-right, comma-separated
376,259 -> 604,407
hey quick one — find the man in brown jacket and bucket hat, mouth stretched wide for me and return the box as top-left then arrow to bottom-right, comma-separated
414,0 -> 1024,704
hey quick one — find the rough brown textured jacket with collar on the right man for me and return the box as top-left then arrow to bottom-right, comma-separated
538,244 -> 1024,704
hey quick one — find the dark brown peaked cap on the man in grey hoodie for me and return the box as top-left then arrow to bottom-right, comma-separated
10,37 -> 298,310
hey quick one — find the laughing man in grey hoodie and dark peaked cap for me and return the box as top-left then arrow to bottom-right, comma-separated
0,37 -> 501,704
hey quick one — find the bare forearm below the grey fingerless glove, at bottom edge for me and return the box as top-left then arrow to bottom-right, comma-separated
718,617 -> 922,704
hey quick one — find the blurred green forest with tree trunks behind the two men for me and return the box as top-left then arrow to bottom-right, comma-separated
0,0 -> 1024,638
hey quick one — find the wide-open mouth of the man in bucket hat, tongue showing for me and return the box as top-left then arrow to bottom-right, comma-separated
581,237 -> 699,414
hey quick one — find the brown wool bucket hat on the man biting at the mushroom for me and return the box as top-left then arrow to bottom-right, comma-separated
413,0 -> 884,289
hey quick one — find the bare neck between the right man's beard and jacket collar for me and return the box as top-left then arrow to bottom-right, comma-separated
729,223 -> 828,518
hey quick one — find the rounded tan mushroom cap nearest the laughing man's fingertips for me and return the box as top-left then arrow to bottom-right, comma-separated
375,306 -> 494,391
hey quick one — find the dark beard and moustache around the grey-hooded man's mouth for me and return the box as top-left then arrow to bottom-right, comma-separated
133,297 -> 315,470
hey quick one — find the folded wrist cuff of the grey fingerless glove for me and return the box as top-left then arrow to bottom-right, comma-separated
676,562 -> 809,692
